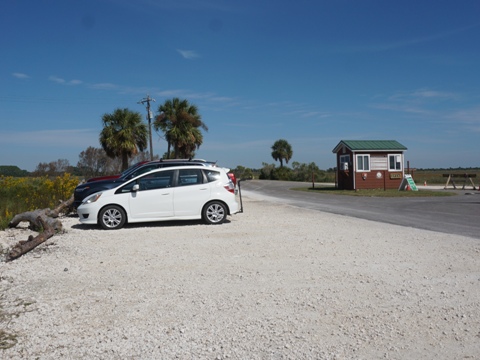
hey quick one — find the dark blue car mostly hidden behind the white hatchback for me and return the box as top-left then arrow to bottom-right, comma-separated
73,159 -> 221,209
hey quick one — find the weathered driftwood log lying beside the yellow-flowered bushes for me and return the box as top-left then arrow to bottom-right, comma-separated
7,195 -> 73,261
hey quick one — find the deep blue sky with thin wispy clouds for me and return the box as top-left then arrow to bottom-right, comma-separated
0,0 -> 480,171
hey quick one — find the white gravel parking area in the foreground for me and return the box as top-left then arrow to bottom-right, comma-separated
0,194 -> 480,359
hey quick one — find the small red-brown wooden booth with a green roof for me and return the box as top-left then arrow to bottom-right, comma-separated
332,140 -> 407,190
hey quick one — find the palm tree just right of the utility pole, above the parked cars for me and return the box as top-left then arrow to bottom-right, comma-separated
153,98 -> 208,159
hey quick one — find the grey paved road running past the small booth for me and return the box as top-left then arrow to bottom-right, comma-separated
241,180 -> 480,239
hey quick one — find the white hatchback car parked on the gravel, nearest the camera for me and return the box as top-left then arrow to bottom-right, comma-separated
77,166 -> 241,230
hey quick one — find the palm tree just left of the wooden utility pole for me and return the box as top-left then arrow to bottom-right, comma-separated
100,109 -> 148,171
